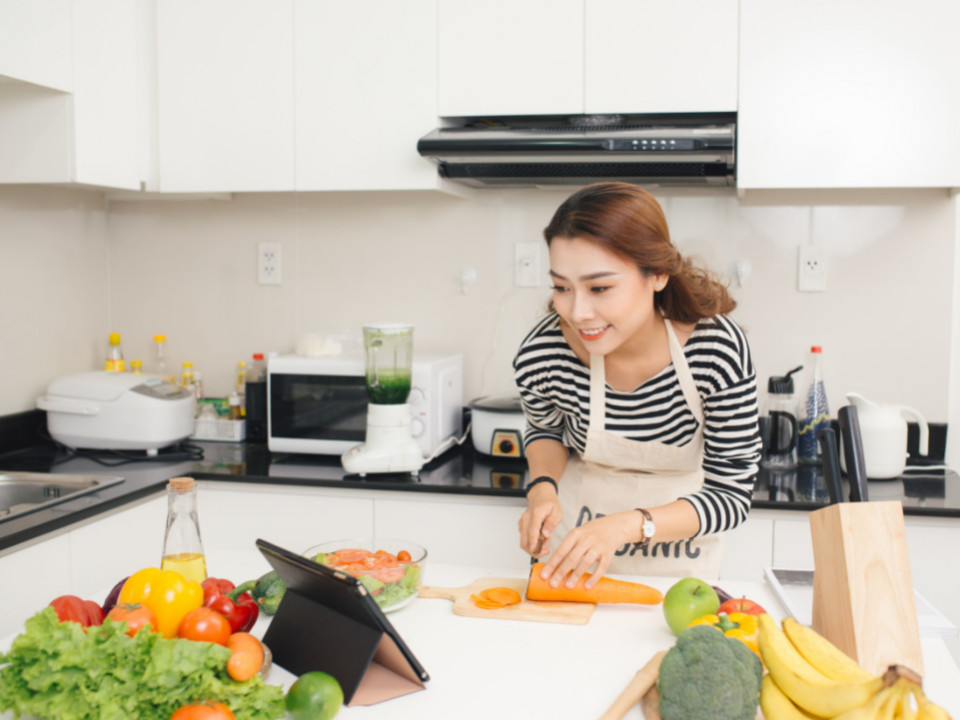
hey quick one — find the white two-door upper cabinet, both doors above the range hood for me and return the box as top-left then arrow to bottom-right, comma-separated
438,0 -> 738,117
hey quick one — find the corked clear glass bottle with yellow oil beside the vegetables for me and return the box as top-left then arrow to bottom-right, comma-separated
160,477 -> 207,582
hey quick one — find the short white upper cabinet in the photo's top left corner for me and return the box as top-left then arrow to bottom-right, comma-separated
0,0 -> 73,92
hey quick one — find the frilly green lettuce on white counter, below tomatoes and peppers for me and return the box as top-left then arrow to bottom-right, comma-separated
0,607 -> 285,720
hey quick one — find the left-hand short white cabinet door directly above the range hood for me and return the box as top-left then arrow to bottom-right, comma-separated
439,0 -> 584,116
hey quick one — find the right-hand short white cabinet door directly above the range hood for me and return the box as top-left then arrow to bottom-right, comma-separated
584,0 -> 738,113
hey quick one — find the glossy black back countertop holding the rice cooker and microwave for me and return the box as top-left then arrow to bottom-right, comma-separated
0,442 -> 960,551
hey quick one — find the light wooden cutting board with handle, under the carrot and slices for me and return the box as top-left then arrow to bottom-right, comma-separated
419,577 -> 597,625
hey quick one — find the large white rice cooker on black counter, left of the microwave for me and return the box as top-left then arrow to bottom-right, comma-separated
37,370 -> 196,450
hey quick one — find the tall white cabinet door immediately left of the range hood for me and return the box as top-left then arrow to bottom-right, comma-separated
294,0 -> 437,190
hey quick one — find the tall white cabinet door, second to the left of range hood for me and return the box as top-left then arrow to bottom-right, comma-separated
157,0 -> 294,192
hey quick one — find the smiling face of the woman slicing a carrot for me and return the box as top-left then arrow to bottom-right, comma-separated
550,237 -> 667,355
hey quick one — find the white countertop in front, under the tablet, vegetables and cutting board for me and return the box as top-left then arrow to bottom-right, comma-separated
0,553 -> 960,720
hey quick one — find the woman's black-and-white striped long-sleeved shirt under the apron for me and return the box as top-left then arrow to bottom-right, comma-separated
513,313 -> 761,535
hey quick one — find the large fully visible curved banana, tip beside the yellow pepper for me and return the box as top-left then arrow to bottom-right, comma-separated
759,615 -> 883,718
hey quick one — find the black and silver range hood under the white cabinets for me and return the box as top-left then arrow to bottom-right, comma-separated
417,113 -> 736,187
